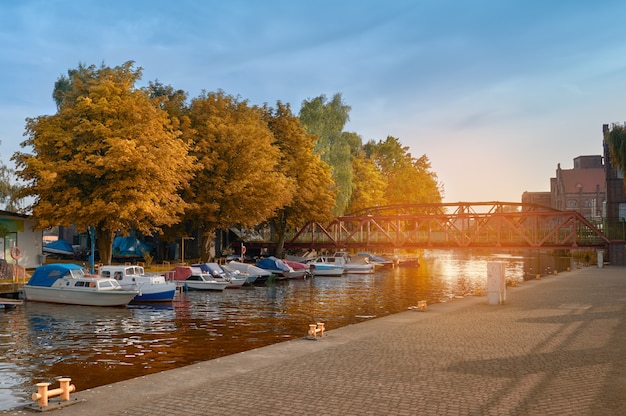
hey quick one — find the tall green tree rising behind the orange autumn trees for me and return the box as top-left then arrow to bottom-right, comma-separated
299,93 -> 358,215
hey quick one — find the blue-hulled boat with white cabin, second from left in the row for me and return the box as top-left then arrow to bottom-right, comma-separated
100,265 -> 176,302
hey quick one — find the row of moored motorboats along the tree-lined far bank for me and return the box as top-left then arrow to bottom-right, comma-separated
22,252 -> 400,306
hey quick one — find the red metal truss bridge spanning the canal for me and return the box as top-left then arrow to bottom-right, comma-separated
285,202 -> 609,250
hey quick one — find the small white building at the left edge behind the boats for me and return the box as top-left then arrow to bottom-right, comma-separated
0,210 -> 45,269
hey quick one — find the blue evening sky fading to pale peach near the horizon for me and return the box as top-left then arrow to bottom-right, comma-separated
0,0 -> 626,202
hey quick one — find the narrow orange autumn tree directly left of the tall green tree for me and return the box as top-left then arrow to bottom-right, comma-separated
264,101 -> 335,257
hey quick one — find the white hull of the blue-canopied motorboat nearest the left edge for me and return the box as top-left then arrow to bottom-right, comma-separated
22,285 -> 137,306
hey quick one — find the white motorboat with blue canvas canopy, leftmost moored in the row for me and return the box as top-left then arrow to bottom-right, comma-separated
22,263 -> 139,306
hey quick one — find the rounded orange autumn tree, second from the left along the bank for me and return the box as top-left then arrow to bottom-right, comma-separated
183,91 -> 295,259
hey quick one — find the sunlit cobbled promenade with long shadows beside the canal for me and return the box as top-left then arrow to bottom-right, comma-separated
0,266 -> 626,416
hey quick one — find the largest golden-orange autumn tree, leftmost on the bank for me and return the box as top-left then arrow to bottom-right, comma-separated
13,62 -> 194,263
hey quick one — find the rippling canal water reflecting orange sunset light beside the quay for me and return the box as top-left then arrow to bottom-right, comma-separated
0,250 -> 570,410
